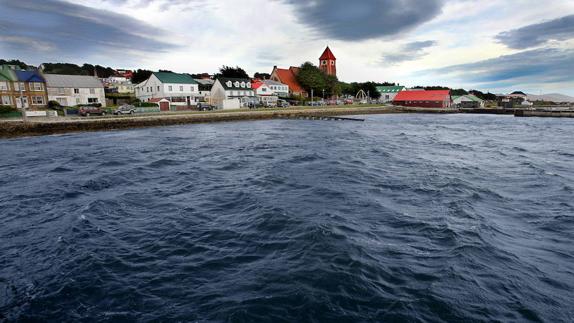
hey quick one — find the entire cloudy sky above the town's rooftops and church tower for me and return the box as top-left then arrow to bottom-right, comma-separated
0,0 -> 574,95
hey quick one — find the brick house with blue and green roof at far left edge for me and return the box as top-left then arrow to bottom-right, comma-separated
0,65 -> 48,109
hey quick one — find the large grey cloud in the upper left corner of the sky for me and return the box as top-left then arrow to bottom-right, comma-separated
0,0 -> 176,59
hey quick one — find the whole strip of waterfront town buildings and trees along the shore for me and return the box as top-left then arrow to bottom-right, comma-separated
0,47 -> 571,118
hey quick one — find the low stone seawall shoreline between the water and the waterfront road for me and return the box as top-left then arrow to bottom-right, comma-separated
0,106 -> 459,138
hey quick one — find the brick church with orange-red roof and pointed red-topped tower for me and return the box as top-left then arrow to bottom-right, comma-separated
271,46 -> 337,98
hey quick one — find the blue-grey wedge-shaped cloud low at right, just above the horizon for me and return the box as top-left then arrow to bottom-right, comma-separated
422,48 -> 574,85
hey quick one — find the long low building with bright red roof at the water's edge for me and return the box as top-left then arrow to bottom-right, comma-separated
393,90 -> 452,108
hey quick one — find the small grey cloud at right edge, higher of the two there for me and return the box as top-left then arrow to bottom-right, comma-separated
496,15 -> 574,49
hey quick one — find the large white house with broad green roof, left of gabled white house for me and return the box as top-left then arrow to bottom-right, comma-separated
135,72 -> 199,107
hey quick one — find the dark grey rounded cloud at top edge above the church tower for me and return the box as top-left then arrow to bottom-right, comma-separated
282,0 -> 443,41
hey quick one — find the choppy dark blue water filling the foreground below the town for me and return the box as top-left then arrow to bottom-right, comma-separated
0,115 -> 574,322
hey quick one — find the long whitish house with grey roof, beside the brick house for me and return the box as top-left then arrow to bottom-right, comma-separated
44,74 -> 106,107
